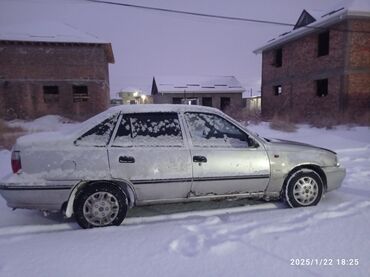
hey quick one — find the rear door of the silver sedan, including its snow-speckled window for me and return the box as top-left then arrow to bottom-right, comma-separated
108,113 -> 192,204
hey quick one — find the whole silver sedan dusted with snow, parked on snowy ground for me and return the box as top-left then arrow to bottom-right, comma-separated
0,105 -> 345,228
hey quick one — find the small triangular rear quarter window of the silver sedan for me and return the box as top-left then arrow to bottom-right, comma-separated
74,114 -> 118,147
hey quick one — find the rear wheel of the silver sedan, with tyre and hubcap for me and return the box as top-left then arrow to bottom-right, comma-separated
73,182 -> 128,229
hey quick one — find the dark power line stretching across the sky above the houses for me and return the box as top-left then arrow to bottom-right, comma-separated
85,0 -> 370,34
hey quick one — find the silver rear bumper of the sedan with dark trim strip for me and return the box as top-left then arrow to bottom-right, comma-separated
0,174 -> 73,211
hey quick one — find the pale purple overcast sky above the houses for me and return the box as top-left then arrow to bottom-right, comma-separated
0,0 -> 341,97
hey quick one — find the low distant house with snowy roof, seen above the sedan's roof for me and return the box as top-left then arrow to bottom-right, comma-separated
151,76 -> 245,111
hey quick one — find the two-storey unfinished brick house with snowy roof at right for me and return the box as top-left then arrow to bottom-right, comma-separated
254,0 -> 370,121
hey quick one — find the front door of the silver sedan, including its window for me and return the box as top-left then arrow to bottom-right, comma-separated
185,112 -> 270,197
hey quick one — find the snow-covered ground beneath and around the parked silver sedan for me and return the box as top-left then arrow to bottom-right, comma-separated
0,120 -> 370,277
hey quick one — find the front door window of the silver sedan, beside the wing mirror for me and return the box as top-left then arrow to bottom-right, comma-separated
185,112 -> 250,148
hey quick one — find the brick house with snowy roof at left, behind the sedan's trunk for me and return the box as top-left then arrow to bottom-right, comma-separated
0,23 -> 114,119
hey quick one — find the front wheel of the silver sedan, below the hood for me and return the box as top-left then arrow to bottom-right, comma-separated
284,170 -> 323,208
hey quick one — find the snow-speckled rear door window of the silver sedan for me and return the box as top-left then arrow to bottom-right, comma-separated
112,113 -> 183,147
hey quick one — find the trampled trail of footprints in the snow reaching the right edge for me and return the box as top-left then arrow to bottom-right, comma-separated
169,201 -> 370,257
